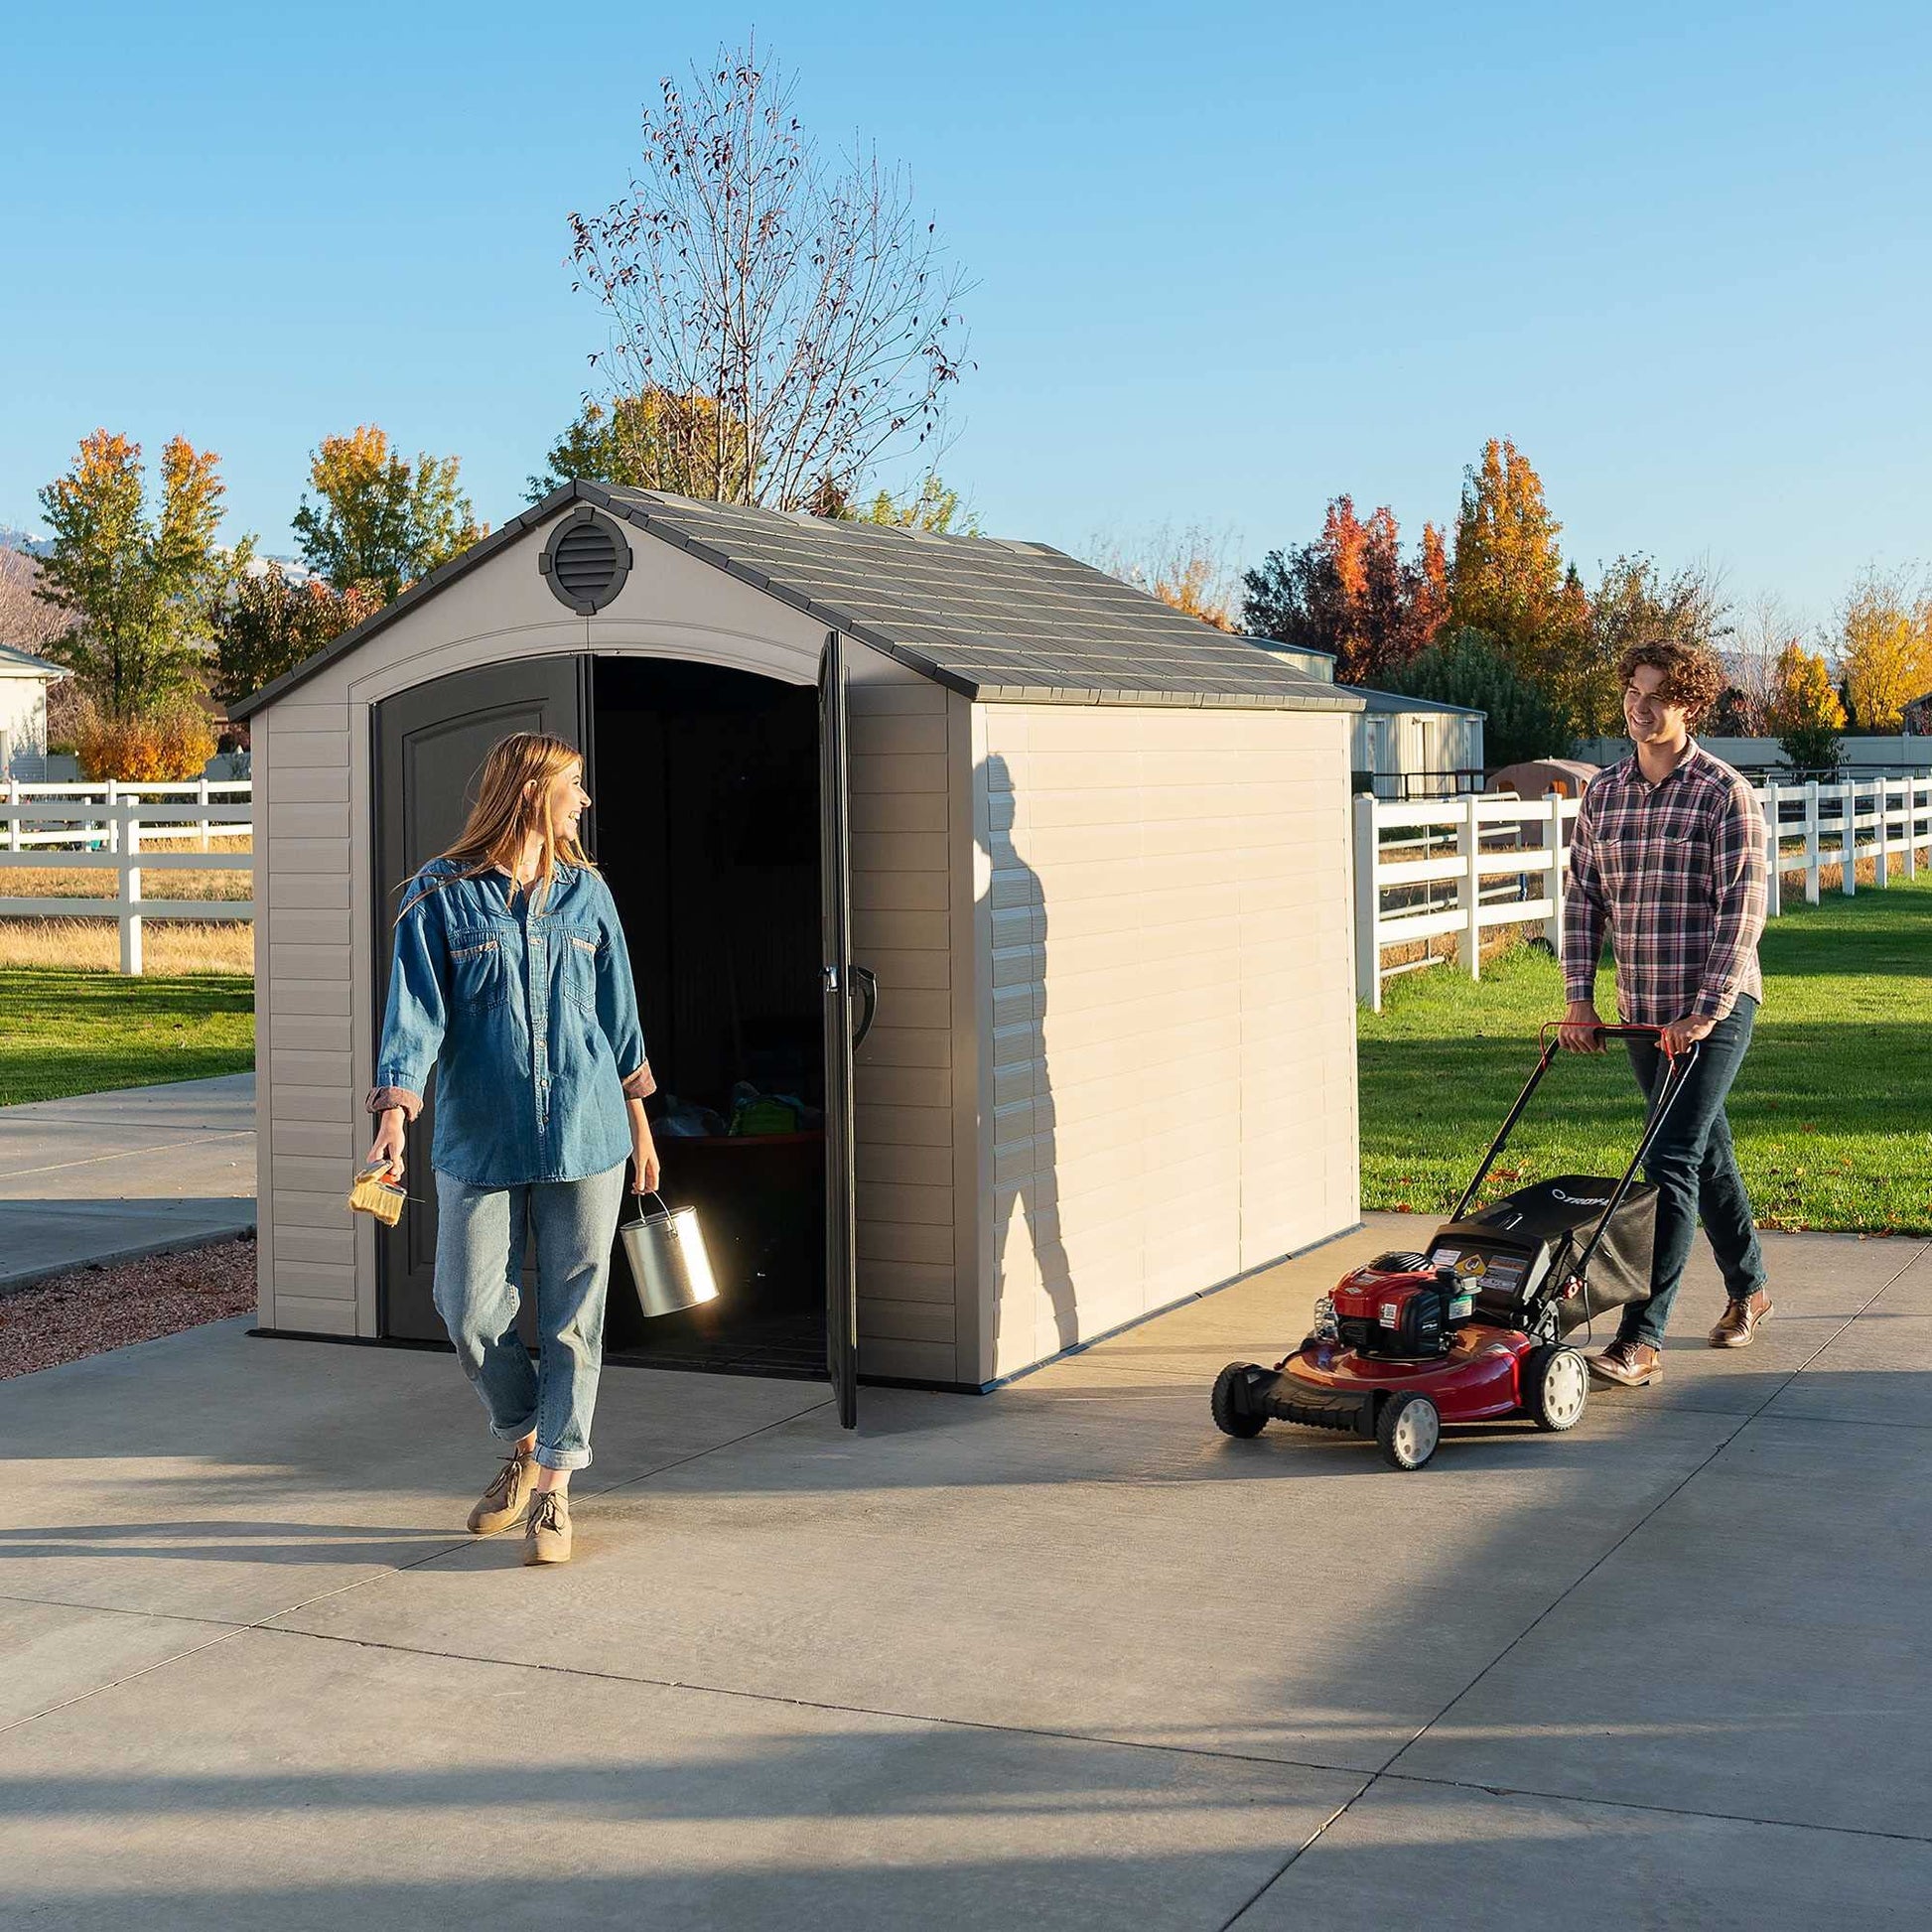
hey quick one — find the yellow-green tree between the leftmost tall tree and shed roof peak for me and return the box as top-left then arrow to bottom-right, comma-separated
294,423 -> 488,603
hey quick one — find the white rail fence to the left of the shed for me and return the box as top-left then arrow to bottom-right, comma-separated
0,778 -> 255,974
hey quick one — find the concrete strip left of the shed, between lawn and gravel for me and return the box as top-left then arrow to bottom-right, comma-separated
0,1074 -> 255,1295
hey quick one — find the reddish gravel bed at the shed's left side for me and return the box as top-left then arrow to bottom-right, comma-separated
0,1234 -> 255,1381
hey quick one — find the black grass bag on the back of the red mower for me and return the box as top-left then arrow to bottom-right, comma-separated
1424,1174 -> 1658,1335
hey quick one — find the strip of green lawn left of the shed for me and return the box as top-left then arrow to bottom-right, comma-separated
0,966 -> 255,1107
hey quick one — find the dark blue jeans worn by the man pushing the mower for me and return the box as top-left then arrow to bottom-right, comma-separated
1617,993 -> 1764,1348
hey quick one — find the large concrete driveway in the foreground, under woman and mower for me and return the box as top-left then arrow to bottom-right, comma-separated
0,1221 -> 1932,1932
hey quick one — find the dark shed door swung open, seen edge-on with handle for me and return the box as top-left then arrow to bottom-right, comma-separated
819,631 -> 877,1430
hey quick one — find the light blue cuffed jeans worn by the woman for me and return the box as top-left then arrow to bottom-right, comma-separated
437,1163 -> 624,1468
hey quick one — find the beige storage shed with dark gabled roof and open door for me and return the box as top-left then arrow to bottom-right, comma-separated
235,483 -> 1360,1420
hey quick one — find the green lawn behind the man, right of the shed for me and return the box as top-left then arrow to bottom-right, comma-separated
1360,874 -> 1932,1234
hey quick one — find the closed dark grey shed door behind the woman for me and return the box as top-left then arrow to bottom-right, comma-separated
369,657 -> 591,1341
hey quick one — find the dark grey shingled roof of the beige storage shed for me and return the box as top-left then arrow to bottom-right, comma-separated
230,482 -> 1360,719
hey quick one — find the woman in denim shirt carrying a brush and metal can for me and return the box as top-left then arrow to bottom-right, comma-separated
369,733 -> 657,1563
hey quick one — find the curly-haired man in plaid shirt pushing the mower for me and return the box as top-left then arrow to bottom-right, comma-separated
1561,643 -> 1771,1389
